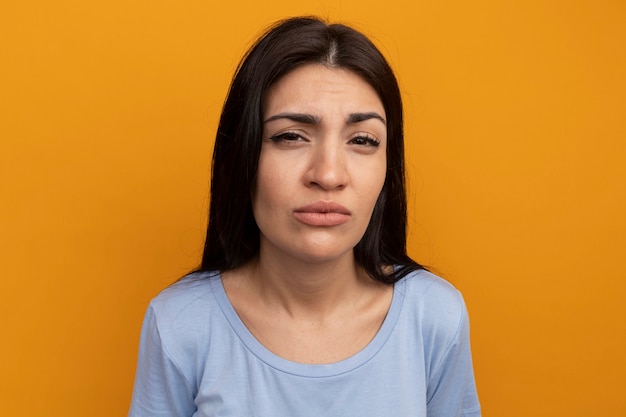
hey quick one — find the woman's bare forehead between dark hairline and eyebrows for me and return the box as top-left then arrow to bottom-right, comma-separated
264,64 -> 385,117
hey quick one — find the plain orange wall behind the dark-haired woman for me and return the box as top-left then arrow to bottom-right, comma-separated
0,0 -> 626,417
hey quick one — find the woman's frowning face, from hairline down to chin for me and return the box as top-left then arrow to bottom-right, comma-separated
252,64 -> 387,262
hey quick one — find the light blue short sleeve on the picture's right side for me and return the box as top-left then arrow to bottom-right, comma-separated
427,295 -> 481,417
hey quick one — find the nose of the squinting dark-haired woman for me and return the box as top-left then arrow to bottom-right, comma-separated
305,140 -> 348,191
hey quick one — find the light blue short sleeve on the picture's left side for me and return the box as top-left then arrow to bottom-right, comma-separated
128,306 -> 196,417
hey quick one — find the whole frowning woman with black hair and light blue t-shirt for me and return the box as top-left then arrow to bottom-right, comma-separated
125,18 -> 480,417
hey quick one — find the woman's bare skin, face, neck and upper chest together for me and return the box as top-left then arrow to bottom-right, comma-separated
223,64 -> 393,363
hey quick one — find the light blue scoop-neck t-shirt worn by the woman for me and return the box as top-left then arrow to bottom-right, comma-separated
129,270 -> 480,417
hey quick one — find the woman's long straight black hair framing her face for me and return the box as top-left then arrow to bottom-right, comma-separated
198,17 -> 422,284
